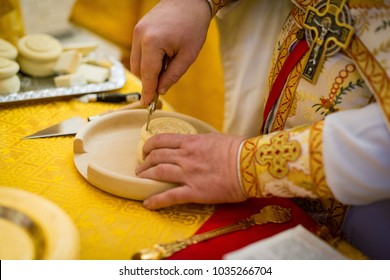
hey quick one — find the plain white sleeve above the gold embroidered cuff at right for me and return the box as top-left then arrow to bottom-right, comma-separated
323,103 -> 390,205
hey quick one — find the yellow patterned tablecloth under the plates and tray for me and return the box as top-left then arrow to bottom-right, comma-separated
0,73 -> 214,259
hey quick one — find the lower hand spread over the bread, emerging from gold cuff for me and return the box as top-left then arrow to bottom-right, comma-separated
136,133 -> 247,209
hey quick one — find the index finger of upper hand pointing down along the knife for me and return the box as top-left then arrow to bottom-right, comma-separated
140,47 -> 165,105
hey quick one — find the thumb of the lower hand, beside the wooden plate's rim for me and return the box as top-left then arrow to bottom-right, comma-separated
144,186 -> 193,210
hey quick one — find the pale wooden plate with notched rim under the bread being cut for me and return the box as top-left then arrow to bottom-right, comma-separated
73,109 -> 217,200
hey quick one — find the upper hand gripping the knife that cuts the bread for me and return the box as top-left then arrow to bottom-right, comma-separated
130,0 -> 211,105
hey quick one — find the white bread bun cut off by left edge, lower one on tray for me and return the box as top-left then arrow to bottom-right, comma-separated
0,57 -> 20,94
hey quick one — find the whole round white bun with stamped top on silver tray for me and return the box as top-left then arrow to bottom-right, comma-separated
17,34 -> 62,77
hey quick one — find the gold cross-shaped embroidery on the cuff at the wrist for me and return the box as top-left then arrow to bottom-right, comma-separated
256,131 -> 301,178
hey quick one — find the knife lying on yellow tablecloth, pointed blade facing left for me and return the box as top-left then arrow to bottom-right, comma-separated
22,100 -> 162,140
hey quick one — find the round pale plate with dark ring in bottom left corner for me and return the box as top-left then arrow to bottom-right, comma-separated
0,186 -> 80,260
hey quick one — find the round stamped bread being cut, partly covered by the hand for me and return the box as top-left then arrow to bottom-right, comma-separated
137,117 -> 198,163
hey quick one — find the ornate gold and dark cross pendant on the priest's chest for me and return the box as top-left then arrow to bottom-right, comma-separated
302,0 -> 354,84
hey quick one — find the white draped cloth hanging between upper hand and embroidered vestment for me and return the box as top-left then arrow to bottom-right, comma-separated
217,0 -> 292,137
